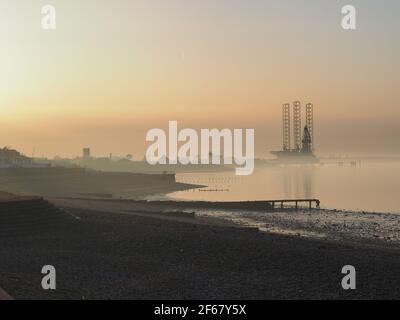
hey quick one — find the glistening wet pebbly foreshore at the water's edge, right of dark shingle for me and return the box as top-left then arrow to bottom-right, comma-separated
197,209 -> 400,249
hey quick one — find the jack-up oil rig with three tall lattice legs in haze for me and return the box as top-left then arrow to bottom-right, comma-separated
271,101 -> 319,164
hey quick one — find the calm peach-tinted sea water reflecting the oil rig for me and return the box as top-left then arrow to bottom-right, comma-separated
169,163 -> 400,213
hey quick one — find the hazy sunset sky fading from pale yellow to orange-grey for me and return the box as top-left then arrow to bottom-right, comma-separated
0,0 -> 400,158
